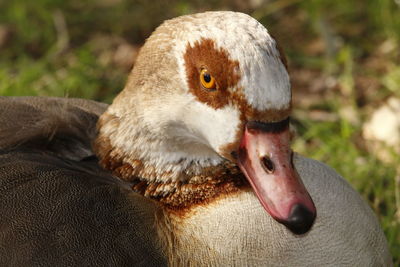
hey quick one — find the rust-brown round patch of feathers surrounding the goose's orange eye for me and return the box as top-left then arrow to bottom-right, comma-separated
184,39 -> 240,109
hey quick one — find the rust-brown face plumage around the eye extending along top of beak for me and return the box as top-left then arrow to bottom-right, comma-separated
184,39 -> 291,122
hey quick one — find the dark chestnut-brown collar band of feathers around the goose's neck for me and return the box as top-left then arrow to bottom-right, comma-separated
94,125 -> 250,216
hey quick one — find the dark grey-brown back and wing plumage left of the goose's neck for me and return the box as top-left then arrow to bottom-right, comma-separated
0,97 -> 166,266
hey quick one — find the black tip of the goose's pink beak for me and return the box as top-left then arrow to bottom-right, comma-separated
282,204 -> 317,235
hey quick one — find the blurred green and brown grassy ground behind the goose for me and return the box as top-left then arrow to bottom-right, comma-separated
0,0 -> 400,266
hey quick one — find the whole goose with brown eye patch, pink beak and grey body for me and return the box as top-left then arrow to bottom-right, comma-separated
0,11 -> 392,266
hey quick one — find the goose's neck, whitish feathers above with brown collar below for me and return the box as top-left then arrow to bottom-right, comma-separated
94,112 -> 245,205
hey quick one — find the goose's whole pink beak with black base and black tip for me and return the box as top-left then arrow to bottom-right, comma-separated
237,118 -> 317,234
